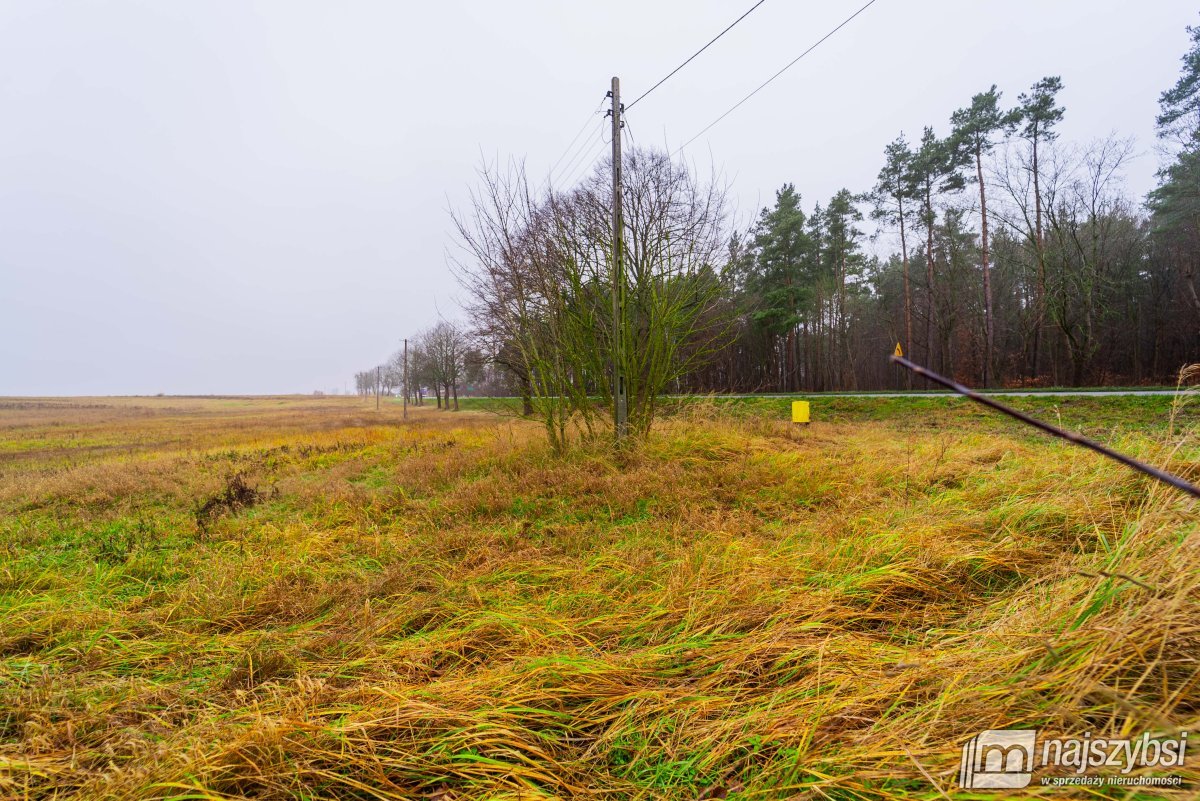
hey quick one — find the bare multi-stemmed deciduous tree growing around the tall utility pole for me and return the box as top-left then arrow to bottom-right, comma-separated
455,150 -> 727,450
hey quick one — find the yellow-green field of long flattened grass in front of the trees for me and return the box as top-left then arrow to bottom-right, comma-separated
0,397 -> 1200,801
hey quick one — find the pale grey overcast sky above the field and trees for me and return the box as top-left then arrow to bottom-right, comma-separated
0,0 -> 1200,395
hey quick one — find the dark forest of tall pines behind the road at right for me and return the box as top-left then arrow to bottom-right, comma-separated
688,57 -> 1200,392
